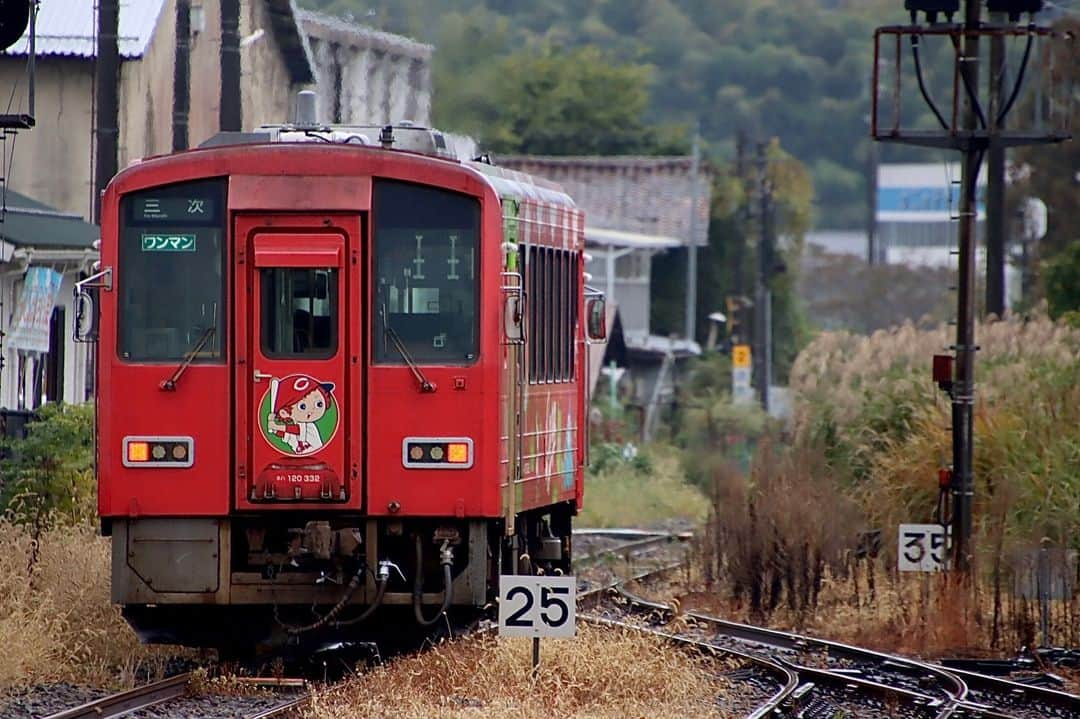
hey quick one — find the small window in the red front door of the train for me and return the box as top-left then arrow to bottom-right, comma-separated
260,268 -> 338,357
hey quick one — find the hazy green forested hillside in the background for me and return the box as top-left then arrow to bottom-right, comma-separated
303,0 -> 904,227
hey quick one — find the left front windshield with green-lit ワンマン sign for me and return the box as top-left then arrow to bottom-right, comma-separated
117,179 -> 229,362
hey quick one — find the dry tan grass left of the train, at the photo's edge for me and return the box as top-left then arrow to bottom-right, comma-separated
0,521 -> 183,692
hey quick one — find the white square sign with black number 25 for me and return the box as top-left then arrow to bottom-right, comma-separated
499,574 -> 577,637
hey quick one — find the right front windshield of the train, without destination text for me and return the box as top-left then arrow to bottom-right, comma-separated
373,180 -> 480,365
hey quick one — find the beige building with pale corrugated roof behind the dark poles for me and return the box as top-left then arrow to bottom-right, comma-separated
0,0 -> 314,218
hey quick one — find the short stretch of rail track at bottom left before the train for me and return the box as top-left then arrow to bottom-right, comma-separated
43,673 -> 310,719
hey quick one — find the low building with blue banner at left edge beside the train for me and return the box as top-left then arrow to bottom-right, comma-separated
0,189 -> 98,409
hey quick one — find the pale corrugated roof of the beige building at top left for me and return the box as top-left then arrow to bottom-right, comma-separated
5,0 -> 165,57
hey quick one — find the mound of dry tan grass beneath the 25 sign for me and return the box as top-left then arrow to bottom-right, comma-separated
306,626 -> 728,719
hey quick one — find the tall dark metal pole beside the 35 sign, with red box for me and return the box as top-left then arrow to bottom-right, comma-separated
953,0 -> 984,572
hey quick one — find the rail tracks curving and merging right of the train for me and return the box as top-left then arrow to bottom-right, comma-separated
579,531 -> 1080,719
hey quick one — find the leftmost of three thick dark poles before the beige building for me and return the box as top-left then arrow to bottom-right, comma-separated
92,0 -> 120,223
